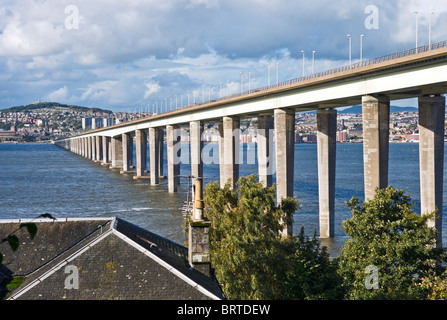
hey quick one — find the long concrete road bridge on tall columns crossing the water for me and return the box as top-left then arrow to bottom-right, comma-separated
54,41 -> 447,246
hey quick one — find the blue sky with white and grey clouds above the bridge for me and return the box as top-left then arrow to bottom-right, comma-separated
0,0 -> 447,112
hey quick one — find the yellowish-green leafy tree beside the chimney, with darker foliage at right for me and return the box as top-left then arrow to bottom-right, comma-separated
204,175 -> 342,300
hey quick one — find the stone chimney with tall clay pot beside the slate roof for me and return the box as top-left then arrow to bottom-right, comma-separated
188,178 -> 211,276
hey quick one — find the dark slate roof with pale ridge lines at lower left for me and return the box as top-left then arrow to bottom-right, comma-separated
0,217 -> 225,300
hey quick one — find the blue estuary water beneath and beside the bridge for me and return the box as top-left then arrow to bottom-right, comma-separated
0,143 -> 447,252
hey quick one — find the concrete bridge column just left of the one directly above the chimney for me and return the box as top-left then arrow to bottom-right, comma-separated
166,125 -> 180,193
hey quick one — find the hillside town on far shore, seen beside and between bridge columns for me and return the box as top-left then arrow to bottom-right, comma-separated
0,102 -> 440,143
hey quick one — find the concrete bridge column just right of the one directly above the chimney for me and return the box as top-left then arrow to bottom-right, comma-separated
220,117 -> 240,189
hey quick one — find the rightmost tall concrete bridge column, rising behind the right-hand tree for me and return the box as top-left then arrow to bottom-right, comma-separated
419,96 -> 445,247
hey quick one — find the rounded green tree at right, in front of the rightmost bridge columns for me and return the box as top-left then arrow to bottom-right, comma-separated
338,187 -> 446,299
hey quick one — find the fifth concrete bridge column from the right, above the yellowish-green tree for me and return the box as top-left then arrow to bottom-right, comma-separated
257,115 -> 274,187
